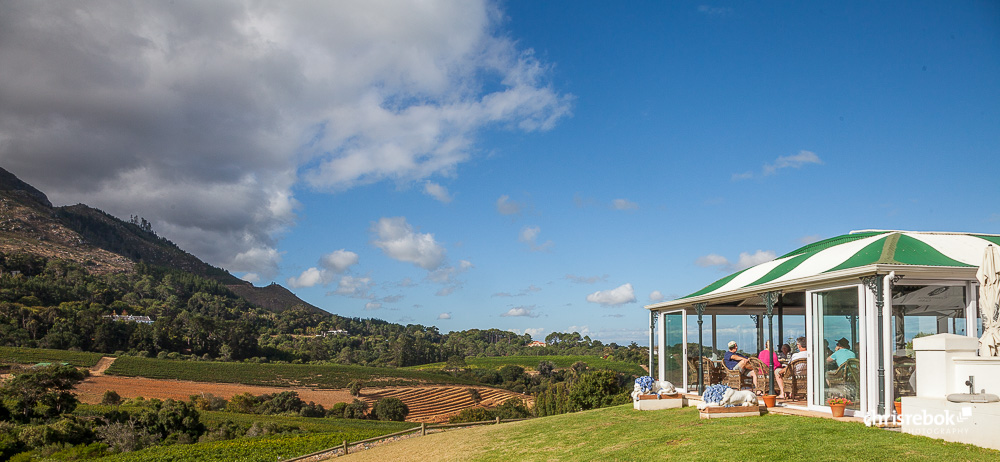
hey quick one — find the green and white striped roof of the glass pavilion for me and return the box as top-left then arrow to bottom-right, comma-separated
667,231 -> 1000,305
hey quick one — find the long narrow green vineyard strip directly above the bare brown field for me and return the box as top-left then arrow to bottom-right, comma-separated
106,356 -> 474,388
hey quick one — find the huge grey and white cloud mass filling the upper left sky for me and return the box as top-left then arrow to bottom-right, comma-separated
0,0 -> 572,277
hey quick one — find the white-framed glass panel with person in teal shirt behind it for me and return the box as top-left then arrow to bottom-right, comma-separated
809,287 -> 861,410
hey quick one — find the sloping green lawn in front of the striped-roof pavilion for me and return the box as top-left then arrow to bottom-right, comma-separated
338,405 -> 1000,462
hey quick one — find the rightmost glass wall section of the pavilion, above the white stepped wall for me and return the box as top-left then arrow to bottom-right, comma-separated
892,284 -> 966,396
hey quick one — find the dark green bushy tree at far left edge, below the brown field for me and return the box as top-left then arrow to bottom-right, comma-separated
0,366 -> 87,421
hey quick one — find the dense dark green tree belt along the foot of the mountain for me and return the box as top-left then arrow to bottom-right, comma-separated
0,253 -> 645,367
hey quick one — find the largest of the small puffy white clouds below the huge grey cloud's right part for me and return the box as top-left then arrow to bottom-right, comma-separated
371,217 -> 445,271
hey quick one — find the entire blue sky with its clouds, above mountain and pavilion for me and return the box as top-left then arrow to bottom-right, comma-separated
0,1 -> 1000,343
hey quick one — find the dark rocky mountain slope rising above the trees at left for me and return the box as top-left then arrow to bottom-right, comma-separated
0,168 -> 326,313
